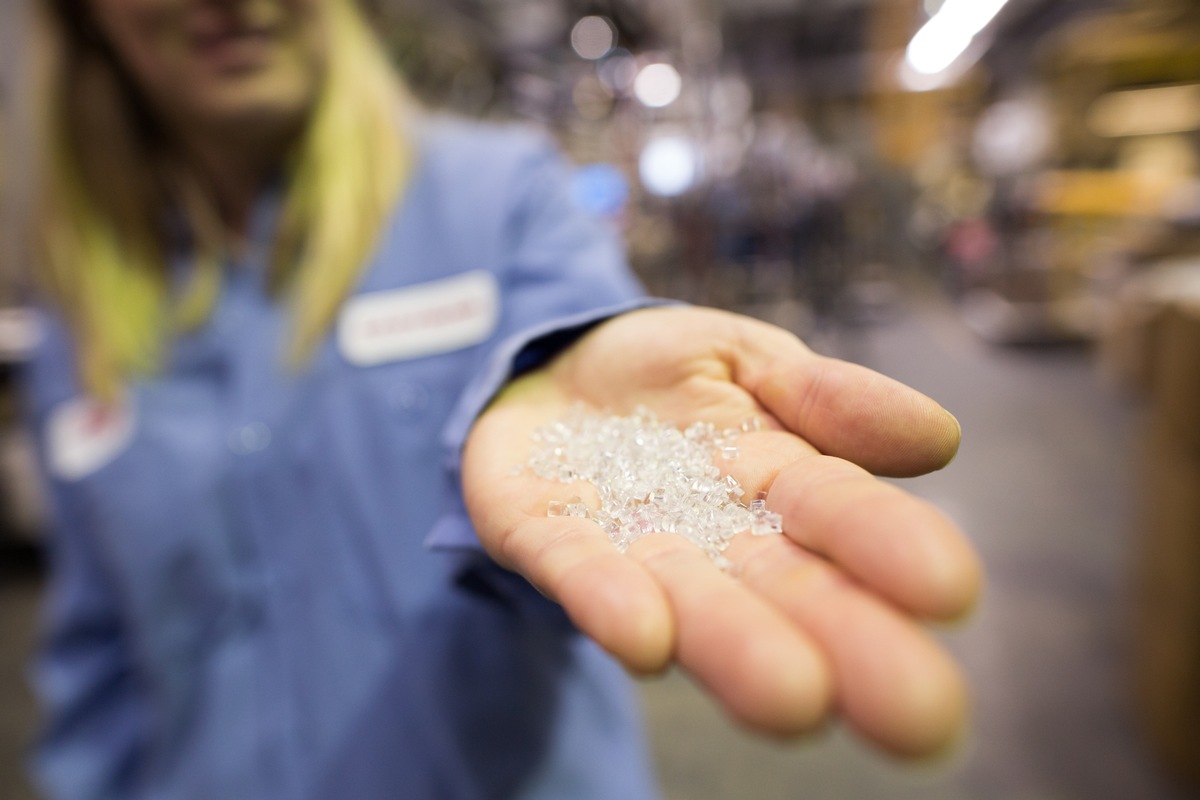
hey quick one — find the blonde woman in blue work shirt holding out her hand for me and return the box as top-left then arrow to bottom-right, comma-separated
29,0 -> 979,799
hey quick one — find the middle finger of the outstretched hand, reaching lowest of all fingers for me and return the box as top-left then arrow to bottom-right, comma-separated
727,536 -> 967,757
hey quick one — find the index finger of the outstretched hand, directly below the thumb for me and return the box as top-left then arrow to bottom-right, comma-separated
767,456 -> 983,620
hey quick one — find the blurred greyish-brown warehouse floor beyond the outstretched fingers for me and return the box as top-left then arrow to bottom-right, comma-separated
0,283 -> 1195,800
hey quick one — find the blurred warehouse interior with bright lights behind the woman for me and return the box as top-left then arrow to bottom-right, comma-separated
0,0 -> 1200,800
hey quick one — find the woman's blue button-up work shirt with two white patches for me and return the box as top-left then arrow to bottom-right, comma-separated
29,122 -> 655,800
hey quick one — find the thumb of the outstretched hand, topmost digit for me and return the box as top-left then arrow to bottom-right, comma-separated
730,311 -> 961,477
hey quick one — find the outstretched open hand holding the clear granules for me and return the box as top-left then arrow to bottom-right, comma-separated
463,308 -> 982,756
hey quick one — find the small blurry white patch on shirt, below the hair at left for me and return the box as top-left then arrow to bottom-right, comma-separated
46,397 -> 134,481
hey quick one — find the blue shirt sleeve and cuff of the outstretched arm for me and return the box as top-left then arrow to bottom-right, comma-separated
426,130 -> 667,549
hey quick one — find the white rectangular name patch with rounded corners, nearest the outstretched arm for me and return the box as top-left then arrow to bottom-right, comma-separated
337,271 -> 500,367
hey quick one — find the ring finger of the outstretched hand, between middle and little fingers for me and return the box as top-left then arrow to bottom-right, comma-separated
629,534 -> 832,735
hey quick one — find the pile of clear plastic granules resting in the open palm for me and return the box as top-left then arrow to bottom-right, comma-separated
524,407 -> 784,569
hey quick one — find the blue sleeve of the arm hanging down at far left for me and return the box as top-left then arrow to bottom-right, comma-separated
24,326 -> 149,800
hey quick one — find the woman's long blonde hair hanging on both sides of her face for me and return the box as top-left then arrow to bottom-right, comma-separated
32,0 -> 412,399
